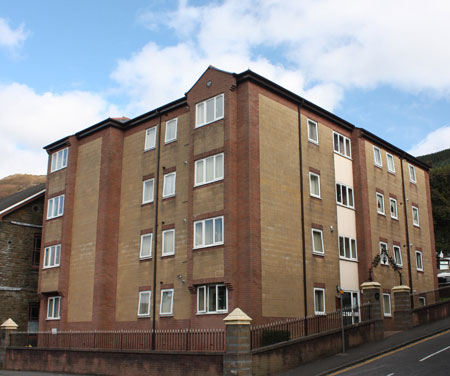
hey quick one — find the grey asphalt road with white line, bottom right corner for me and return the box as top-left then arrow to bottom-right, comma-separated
329,330 -> 450,376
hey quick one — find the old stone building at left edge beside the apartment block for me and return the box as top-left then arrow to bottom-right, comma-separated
0,184 -> 45,331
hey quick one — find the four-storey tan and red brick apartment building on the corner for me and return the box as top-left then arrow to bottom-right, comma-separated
39,67 -> 437,330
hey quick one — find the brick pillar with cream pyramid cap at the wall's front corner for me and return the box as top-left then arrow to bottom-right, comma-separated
223,308 -> 252,376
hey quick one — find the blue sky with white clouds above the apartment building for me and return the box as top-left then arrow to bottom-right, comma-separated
0,0 -> 450,179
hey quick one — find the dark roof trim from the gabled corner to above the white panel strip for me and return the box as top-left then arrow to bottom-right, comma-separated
235,70 -> 356,131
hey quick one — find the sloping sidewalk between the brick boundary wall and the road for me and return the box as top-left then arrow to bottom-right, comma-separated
278,317 -> 450,376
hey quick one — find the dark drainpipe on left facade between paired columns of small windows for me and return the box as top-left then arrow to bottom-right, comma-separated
152,111 -> 162,350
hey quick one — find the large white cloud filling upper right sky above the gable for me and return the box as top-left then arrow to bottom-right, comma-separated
128,0 -> 450,104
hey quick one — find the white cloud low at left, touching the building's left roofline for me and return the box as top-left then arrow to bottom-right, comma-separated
0,83 -> 119,178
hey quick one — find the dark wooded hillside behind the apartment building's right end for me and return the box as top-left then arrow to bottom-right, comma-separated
418,149 -> 450,254
